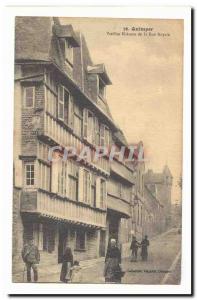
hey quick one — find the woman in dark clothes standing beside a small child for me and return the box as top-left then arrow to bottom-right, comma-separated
60,247 -> 73,283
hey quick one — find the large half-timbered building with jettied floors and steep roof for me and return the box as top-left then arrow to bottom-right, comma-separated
13,17 -> 134,282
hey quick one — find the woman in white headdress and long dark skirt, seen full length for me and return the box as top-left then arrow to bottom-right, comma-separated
104,239 -> 124,283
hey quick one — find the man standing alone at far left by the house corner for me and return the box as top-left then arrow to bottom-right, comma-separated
22,239 -> 40,282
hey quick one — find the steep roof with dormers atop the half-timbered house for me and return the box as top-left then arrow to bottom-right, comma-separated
15,17 -> 115,126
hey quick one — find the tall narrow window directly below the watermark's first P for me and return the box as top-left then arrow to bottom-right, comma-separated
68,161 -> 78,201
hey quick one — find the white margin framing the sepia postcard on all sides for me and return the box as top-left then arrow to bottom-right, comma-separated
0,6 -> 191,295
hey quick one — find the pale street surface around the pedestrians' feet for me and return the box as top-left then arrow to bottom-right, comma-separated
41,229 -> 181,284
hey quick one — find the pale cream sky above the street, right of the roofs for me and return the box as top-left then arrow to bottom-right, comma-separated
61,18 -> 183,202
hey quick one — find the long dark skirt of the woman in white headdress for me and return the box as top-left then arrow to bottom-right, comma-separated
104,258 -> 122,283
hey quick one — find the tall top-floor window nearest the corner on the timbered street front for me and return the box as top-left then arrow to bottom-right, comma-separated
58,85 -> 70,124
